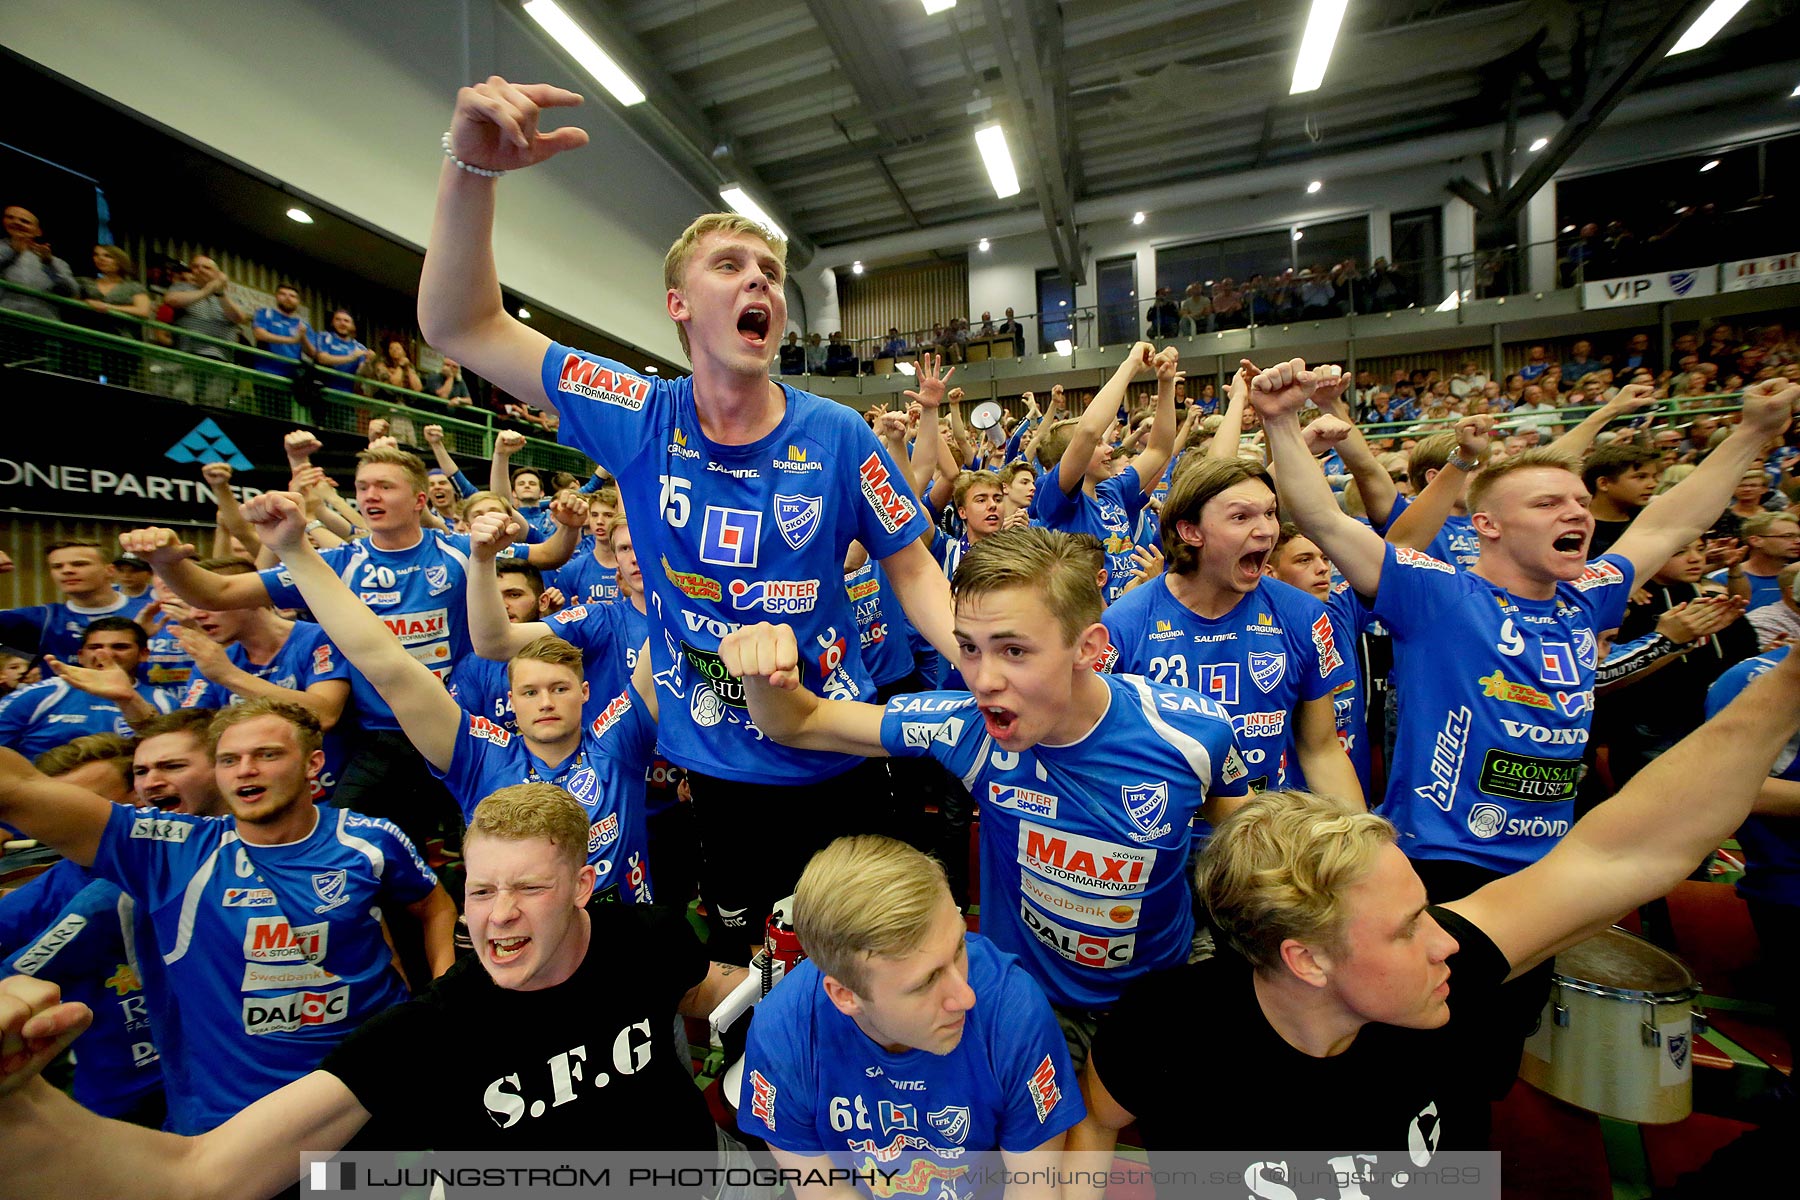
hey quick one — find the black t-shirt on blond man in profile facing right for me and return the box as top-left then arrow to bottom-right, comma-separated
1091,907 -> 1521,1165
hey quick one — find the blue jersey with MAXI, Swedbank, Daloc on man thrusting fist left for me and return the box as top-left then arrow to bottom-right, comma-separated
882,675 -> 1247,1009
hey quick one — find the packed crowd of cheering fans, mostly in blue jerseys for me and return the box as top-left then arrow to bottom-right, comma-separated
0,77 -> 1800,1200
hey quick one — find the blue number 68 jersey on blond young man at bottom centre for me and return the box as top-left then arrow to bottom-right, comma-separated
738,934 -> 1087,1200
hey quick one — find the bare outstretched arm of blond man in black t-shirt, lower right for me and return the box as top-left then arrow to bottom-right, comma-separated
1449,653 -> 1800,975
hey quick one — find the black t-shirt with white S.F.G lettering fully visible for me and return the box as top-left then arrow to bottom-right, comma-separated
320,900 -> 715,1150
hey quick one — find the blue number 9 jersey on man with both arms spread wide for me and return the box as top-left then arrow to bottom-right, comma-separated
1375,543 -> 1633,874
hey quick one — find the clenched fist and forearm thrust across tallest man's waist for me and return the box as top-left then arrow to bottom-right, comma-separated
718,626 -> 889,757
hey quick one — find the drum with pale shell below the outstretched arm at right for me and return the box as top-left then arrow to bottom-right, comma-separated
1519,927 -> 1699,1124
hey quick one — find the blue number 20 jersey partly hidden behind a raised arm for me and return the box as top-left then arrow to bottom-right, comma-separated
259,529 -> 504,729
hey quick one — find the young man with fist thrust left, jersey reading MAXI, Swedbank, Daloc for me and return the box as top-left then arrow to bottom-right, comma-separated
720,529 -> 1246,1056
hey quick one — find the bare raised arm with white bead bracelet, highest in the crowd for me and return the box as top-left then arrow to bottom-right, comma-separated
419,76 -> 587,408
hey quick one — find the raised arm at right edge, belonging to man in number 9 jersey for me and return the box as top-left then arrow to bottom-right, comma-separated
1613,380 -> 1800,579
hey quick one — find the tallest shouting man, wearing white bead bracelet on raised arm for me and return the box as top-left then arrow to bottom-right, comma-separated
419,76 -> 954,941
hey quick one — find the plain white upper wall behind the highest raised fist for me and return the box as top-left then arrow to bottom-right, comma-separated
5,0 -> 718,362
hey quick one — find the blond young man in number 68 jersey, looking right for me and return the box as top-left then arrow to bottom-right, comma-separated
738,837 -> 1084,1200
